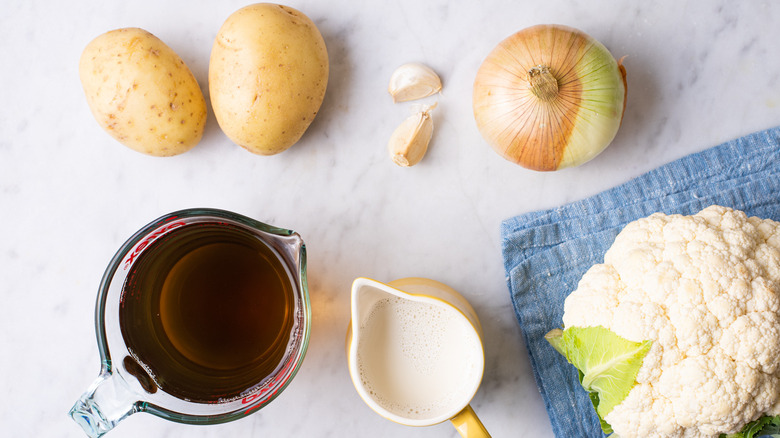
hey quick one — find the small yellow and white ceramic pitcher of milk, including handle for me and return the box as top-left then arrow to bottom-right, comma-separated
347,278 -> 490,438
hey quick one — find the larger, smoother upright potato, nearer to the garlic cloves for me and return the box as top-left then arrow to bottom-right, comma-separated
209,3 -> 328,155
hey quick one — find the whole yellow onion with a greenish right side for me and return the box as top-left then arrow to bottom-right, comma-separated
473,25 -> 626,171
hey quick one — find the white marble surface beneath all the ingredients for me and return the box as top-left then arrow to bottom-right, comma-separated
0,0 -> 780,438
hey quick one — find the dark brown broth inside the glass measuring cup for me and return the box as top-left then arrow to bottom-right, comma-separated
119,223 -> 295,403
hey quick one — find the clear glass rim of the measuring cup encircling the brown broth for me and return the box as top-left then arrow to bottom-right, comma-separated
95,208 -> 311,424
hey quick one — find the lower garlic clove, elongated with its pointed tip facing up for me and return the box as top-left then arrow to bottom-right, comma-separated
387,104 -> 436,167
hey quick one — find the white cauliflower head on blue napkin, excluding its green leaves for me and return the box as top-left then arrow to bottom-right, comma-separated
563,206 -> 780,438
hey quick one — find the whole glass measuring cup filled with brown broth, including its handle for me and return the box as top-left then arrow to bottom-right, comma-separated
69,209 -> 311,438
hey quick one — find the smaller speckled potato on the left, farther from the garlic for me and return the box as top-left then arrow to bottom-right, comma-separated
79,28 -> 206,157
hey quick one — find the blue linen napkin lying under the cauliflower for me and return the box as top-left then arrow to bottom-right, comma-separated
501,127 -> 780,438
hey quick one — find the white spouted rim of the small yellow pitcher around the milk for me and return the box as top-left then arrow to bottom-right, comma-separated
348,277 -> 485,426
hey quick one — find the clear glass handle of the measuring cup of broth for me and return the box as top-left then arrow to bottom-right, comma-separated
69,372 -> 140,438
